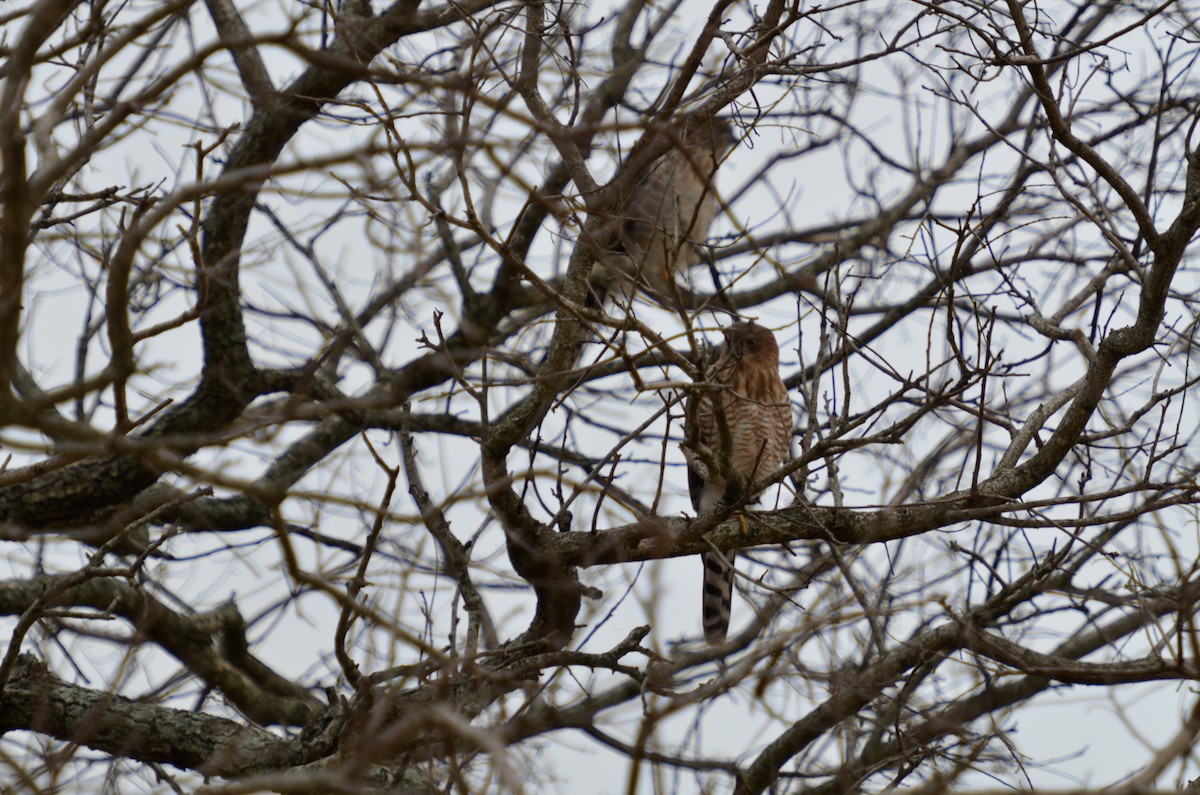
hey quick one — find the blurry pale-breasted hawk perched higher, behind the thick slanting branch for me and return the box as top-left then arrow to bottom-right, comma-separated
594,119 -> 738,303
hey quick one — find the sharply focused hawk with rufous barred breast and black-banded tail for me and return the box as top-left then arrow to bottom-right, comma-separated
683,321 -> 793,646
